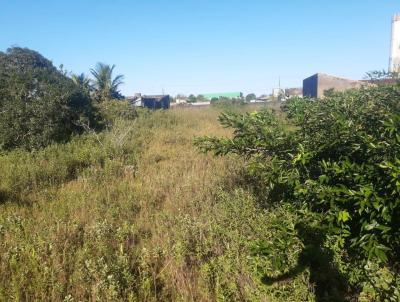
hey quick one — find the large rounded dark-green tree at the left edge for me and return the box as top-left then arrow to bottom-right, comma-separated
0,47 -> 94,149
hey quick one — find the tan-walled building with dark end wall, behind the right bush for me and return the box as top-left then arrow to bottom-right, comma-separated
303,73 -> 368,98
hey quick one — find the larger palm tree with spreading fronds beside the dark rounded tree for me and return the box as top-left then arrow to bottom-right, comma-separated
90,63 -> 124,100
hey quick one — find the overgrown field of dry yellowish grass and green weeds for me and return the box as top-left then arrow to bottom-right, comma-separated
0,108 -> 394,301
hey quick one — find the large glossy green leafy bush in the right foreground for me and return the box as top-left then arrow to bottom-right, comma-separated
196,85 -> 400,280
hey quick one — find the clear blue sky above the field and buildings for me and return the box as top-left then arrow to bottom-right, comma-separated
0,0 -> 400,95
